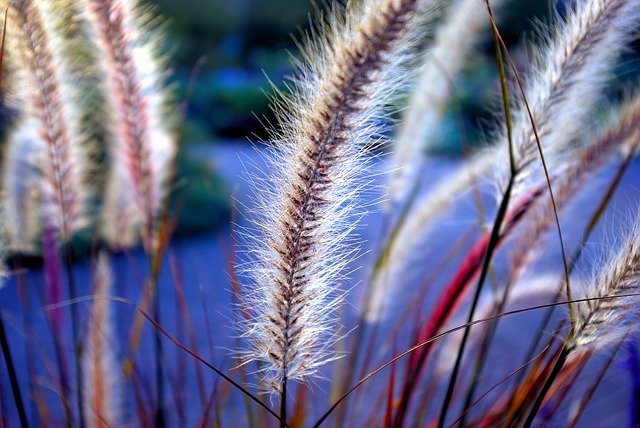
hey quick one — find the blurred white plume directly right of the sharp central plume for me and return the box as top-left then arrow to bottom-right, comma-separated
389,0 -> 504,205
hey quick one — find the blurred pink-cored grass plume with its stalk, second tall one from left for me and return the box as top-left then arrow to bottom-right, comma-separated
86,0 -> 176,425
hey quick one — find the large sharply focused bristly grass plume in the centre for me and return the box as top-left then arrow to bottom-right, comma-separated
243,0 -> 436,392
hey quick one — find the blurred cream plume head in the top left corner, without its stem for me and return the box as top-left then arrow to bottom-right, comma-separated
8,0 -> 88,240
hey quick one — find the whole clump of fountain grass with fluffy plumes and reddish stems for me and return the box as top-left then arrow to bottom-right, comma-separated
0,0 -> 640,428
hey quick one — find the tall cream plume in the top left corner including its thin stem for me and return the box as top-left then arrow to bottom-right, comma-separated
6,0 -> 87,426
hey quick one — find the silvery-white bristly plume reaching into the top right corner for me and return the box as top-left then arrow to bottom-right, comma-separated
499,0 -> 640,193
